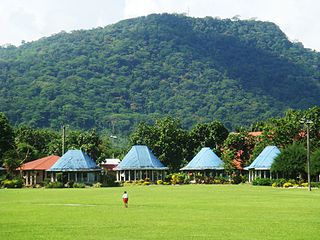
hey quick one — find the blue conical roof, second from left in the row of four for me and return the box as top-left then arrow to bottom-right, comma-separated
114,145 -> 168,170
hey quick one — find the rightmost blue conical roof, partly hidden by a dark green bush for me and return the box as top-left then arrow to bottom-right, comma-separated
244,146 -> 280,170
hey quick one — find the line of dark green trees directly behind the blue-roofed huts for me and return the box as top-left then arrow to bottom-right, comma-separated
0,107 -> 320,178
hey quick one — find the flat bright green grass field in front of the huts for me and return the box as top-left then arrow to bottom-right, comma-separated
0,185 -> 320,240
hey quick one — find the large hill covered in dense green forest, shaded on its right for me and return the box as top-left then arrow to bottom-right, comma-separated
0,14 -> 320,133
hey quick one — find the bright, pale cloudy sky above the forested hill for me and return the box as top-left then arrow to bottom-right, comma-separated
0,0 -> 320,52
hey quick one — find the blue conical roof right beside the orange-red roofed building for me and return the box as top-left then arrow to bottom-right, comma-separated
47,150 -> 100,172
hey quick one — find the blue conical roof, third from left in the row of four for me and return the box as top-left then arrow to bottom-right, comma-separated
180,147 -> 224,171
